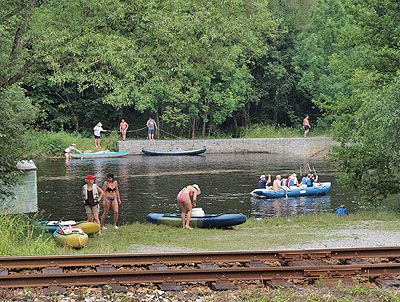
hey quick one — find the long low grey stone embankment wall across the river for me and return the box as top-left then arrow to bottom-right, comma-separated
118,137 -> 336,158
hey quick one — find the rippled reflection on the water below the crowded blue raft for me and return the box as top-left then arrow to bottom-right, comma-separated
251,195 -> 331,218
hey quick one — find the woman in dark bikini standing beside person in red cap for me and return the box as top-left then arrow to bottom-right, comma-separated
100,173 -> 121,230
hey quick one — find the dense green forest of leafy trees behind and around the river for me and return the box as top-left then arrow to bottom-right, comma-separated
0,0 -> 400,200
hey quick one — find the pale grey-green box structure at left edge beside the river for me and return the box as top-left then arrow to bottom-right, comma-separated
0,160 -> 38,214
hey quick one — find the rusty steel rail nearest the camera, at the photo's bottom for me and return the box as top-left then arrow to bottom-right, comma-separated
0,263 -> 400,288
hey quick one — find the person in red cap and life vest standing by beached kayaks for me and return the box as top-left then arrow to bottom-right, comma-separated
81,174 -> 104,234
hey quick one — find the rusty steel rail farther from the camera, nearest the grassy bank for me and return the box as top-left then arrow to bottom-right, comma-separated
0,247 -> 400,269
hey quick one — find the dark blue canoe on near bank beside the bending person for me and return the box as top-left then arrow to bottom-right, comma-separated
146,213 -> 247,228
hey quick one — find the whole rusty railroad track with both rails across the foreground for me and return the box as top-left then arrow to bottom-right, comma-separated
0,247 -> 400,291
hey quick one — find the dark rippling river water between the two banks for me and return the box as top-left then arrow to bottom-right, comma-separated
35,153 -> 357,224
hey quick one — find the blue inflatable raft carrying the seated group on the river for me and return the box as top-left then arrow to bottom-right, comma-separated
250,182 -> 331,198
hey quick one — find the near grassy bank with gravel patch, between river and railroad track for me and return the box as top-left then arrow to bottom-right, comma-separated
0,211 -> 400,256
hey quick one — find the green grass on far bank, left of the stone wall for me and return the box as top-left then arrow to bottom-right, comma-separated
24,131 -> 120,158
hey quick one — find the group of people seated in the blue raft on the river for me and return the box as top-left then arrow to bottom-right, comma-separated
258,173 -> 318,191
